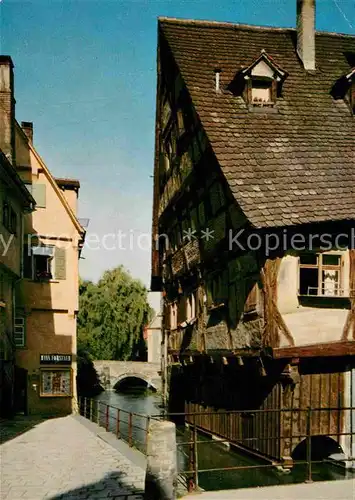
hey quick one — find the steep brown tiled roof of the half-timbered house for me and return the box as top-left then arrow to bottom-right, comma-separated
159,18 -> 355,227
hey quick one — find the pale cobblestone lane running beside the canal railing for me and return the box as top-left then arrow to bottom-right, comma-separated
0,416 -> 144,500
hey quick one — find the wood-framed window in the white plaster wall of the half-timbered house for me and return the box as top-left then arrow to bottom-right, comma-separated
299,253 -> 344,297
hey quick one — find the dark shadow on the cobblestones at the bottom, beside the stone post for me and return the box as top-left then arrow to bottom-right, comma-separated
49,471 -> 145,500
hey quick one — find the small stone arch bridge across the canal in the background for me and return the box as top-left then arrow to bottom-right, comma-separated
94,360 -> 161,391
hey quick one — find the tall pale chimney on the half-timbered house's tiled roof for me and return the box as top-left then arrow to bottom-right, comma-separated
297,0 -> 316,71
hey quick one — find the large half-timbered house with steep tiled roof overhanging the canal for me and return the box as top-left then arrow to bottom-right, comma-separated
152,0 -> 355,464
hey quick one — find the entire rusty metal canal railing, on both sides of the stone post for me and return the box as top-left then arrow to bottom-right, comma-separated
79,398 -> 355,492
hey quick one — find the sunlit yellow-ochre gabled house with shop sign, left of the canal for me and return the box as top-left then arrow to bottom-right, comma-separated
0,55 -> 84,415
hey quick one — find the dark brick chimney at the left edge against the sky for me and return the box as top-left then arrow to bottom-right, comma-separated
0,56 -> 15,164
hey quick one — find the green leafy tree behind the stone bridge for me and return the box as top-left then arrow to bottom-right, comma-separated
78,266 -> 152,361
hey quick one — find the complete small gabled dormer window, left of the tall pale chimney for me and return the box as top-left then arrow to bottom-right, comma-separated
239,50 -> 287,107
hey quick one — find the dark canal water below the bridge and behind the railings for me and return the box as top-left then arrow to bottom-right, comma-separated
96,388 -> 350,491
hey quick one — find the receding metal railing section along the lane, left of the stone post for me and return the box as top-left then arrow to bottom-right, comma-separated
79,397 -> 152,454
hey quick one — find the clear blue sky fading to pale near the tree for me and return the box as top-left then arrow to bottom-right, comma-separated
0,0 -> 355,308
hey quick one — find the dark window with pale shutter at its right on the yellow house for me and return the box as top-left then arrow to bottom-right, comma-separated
24,245 -> 66,281
